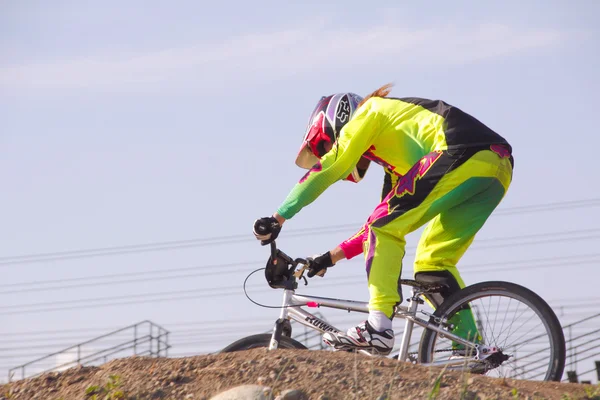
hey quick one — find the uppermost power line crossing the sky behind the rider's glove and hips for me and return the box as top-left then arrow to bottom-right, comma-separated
0,198 -> 600,266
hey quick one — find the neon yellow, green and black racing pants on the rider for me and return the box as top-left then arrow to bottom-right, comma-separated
364,146 -> 512,317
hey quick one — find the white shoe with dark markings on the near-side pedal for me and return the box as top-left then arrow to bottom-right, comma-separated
323,321 -> 395,355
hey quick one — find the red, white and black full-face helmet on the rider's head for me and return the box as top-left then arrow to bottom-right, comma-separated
296,93 -> 362,169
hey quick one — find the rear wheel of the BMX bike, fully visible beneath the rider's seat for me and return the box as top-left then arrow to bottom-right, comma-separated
419,282 -> 565,381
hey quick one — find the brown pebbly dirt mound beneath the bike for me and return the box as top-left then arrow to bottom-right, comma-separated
0,349 -> 600,400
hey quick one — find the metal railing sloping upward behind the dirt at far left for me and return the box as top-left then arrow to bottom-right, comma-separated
8,321 -> 171,382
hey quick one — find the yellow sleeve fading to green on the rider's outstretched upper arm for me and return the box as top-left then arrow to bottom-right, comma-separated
277,101 -> 382,219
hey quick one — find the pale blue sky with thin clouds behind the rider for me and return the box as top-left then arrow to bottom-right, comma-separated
0,0 -> 600,379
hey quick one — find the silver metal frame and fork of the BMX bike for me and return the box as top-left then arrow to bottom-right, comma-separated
269,288 -> 484,366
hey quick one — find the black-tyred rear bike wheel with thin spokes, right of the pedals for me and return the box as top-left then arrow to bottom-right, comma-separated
419,281 -> 566,381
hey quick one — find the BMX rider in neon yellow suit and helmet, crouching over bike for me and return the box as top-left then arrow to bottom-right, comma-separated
254,84 -> 513,354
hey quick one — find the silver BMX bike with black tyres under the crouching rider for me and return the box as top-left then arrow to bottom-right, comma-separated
221,242 -> 565,381
